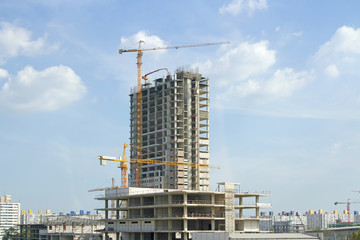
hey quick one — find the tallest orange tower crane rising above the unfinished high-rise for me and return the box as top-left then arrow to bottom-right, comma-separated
119,40 -> 229,187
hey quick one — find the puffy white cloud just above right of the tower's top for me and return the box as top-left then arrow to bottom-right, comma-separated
193,41 -> 276,86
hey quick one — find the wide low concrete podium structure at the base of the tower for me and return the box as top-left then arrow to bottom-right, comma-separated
97,183 -> 271,240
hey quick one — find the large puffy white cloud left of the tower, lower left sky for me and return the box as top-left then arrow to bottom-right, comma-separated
0,65 -> 86,111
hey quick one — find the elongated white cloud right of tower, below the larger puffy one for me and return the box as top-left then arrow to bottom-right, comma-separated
217,68 -> 312,104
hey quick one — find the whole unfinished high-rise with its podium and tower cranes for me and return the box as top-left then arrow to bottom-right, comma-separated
89,41 -> 271,240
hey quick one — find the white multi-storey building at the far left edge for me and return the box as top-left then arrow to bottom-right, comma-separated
0,195 -> 20,239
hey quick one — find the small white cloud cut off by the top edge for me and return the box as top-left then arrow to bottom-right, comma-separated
219,0 -> 267,15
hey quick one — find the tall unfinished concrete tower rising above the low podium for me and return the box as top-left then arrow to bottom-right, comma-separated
129,70 -> 209,190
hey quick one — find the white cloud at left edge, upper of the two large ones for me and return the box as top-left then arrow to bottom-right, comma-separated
0,22 -> 45,62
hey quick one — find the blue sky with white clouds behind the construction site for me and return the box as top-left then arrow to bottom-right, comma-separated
0,0 -> 360,212
